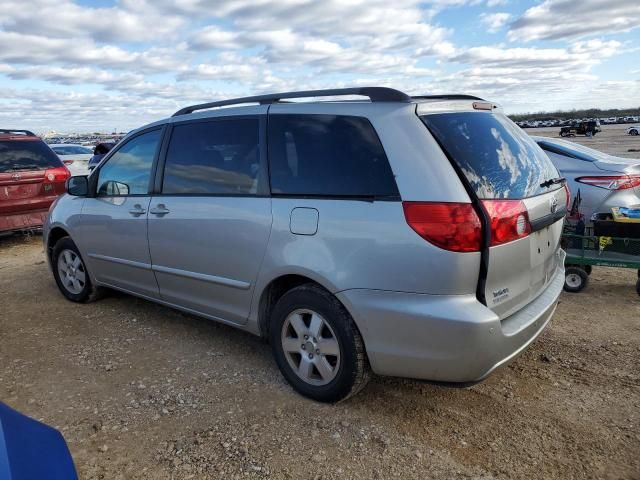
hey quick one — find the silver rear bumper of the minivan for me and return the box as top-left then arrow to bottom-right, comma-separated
338,262 -> 564,383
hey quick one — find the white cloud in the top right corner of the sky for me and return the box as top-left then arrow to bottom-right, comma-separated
508,0 -> 640,41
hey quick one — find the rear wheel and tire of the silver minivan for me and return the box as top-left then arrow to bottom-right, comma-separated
269,283 -> 370,403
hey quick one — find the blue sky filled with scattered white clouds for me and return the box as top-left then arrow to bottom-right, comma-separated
0,0 -> 640,132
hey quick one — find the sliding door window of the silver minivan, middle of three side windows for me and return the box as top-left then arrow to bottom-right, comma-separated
162,118 -> 262,195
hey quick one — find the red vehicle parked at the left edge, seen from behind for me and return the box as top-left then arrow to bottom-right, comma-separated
0,129 -> 71,233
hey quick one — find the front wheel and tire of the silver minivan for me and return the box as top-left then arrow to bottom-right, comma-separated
51,237 -> 103,303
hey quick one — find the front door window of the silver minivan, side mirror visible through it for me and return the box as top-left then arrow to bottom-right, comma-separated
98,130 -> 161,197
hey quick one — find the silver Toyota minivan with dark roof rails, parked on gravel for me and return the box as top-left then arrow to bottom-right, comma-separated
44,87 -> 568,402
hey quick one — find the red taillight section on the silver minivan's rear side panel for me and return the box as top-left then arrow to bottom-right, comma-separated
402,202 -> 482,252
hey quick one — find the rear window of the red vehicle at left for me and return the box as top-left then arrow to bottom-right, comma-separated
0,140 -> 63,173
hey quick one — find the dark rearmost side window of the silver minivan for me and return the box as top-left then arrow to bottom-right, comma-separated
269,114 -> 398,197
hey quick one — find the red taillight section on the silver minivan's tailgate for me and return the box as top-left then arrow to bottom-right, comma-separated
482,200 -> 531,247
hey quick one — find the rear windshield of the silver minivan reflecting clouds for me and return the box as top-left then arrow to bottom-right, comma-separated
420,112 -> 562,199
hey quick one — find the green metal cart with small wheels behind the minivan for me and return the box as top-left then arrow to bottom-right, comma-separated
561,231 -> 640,295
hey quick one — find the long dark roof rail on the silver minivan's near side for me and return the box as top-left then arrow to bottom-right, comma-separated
172,87 -> 411,117
